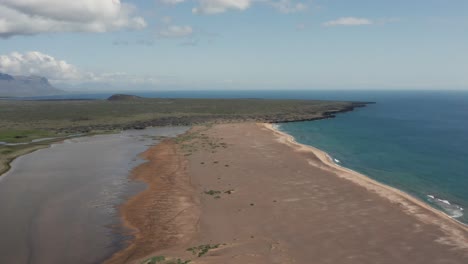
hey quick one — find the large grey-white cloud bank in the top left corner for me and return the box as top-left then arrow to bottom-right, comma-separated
0,0 -> 146,37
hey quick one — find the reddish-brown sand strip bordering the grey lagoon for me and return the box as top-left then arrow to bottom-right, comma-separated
103,136 -> 199,264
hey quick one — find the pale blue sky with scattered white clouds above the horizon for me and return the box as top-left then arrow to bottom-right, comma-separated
0,0 -> 468,91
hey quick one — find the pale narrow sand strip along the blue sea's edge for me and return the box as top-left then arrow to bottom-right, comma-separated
260,123 -> 468,245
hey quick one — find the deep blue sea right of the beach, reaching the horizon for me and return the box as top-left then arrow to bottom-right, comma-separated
15,91 -> 468,223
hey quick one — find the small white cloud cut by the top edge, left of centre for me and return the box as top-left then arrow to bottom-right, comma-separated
192,0 -> 252,14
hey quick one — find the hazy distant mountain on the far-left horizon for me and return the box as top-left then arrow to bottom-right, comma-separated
0,73 -> 64,97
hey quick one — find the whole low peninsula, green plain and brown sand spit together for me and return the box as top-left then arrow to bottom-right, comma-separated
0,95 -> 468,264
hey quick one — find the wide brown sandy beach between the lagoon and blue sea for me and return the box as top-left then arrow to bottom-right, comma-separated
107,123 -> 468,263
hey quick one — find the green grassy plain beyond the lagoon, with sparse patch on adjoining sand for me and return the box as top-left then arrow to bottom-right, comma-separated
0,95 -> 363,174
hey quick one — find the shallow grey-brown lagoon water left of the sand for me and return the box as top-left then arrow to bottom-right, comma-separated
0,127 -> 187,264
